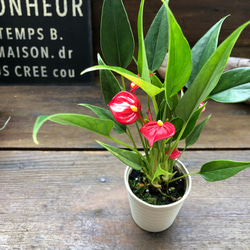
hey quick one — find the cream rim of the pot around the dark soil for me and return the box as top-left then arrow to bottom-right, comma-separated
124,159 -> 192,209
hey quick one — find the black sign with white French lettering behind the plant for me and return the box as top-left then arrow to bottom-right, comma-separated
0,0 -> 93,85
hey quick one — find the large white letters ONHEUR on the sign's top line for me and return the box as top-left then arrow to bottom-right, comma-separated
0,0 -> 83,17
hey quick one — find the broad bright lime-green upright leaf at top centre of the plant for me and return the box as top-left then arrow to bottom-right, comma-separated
164,1 -> 192,109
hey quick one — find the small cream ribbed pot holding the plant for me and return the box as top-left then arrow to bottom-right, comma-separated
124,160 -> 192,232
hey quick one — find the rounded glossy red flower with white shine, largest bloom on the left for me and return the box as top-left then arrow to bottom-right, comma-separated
109,91 -> 141,125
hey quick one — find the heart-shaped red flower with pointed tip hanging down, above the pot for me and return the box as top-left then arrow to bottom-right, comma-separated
140,120 -> 175,148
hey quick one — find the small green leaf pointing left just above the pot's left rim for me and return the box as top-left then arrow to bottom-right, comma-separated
96,141 -> 143,170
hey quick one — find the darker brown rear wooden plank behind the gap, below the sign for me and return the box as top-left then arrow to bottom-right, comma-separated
0,86 -> 250,149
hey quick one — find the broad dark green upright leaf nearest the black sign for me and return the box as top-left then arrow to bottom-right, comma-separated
100,0 -> 134,68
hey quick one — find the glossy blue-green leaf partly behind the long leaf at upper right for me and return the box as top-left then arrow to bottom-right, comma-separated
186,17 -> 227,87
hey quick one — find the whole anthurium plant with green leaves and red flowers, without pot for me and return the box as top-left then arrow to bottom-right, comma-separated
33,0 -> 250,205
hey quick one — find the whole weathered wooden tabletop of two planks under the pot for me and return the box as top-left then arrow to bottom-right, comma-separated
0,86 -> 250,250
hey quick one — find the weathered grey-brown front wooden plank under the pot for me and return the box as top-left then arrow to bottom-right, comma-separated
0,150 -> 250,250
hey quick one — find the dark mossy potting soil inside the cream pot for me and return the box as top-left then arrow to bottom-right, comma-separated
129,167 -> 186,205
